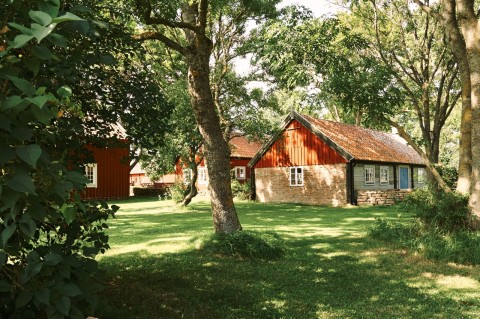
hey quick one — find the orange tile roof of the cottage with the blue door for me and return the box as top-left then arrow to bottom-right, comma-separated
302,114 -> 425,165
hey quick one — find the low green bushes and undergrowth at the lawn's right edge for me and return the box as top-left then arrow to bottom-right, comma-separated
368,190 -> 480,264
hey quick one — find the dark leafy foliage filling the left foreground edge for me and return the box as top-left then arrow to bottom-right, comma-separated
0,0 -> 118,319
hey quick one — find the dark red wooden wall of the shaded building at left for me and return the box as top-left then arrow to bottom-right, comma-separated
83,145 -> 130,199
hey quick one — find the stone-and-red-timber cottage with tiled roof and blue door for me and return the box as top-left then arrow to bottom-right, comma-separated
249,112 -> 425,206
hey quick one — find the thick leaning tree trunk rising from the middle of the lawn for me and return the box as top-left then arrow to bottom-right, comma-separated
183,5 -> 242,233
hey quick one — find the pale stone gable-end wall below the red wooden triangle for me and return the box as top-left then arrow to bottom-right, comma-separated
255,164 -> 347,206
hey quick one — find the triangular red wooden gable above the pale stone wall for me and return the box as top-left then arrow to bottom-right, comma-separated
255,120 -> 347,168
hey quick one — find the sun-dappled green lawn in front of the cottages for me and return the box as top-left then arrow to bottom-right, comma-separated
100,200 -> 480,319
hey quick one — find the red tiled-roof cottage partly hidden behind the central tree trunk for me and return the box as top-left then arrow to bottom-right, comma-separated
179,135 -> 262,192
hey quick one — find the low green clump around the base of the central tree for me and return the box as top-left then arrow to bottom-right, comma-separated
193,231 -> 285,260
